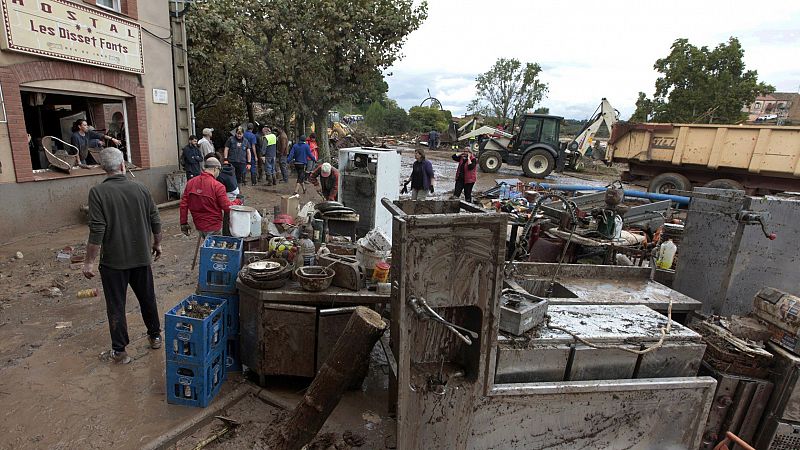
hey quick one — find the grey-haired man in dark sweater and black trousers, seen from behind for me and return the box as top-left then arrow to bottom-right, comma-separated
83,148 -> 161,364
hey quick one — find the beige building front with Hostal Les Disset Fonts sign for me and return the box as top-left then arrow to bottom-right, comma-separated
0,0 -> 179,238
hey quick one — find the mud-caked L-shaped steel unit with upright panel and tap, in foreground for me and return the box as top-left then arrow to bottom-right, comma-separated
383,201 -> 716,450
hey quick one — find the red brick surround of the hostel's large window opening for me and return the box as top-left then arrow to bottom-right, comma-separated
0,60 -> 150,183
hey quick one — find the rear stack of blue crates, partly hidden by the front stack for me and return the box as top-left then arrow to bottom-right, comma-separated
197,236 -> 244,372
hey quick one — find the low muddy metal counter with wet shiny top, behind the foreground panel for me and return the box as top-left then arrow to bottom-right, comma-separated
495,305 -> 705,383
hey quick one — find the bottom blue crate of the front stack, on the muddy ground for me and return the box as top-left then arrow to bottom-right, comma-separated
166,346 -> 228,408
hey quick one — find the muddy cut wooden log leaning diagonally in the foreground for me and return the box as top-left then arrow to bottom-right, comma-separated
269,306 -> 386,450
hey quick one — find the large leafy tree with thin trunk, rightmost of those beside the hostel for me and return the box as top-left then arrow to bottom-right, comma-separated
260,0 -> 427,160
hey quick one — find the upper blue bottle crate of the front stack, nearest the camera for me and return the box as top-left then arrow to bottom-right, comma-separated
164,295 -> 228,365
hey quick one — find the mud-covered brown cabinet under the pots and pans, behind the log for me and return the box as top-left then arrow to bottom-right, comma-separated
237,280 -> 389,382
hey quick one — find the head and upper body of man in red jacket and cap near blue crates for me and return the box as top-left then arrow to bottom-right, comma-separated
180,158 -> 231,239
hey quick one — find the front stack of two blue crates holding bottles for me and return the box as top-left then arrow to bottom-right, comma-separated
164,295 -> 228,408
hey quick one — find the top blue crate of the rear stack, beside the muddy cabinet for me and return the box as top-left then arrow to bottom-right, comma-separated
197,236 -> 243,294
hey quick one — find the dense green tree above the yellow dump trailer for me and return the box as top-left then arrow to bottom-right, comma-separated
631,37 -> 775,123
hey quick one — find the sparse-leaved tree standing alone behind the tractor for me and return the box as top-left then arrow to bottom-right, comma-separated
467,58 -> 547,123
